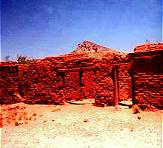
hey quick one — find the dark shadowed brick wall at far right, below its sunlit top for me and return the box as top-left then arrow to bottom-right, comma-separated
133,50 -> 163,106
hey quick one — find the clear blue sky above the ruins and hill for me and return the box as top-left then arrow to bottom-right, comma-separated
1,0 -> 162,59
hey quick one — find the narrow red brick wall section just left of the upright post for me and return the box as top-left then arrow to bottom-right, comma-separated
91,58 -> 114,106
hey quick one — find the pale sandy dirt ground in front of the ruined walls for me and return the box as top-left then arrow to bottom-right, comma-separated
0,104 -> 163,148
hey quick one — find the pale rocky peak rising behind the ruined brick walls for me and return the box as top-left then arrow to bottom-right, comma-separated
43,41 -> 128,61
